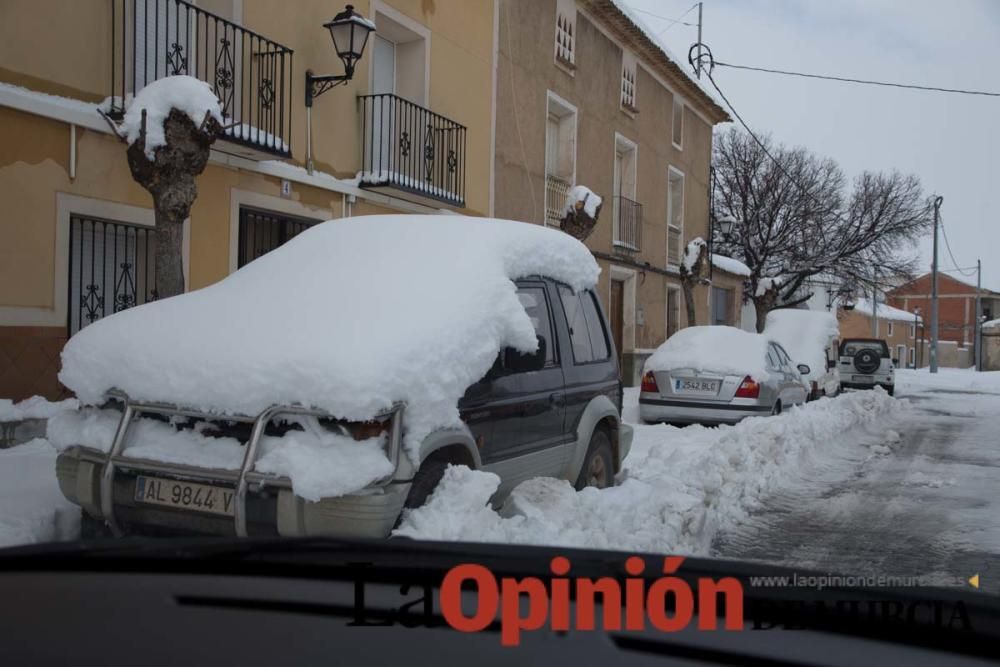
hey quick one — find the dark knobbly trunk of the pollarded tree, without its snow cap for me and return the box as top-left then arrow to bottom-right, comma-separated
128,109 -> 221,299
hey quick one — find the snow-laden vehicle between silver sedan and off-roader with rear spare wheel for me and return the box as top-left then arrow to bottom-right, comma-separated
764,308 -> 840,401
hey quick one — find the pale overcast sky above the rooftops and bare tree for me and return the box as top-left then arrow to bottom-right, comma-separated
626,0 -> 1000,291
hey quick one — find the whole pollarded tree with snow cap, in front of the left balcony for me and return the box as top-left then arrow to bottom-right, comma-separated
103,76 -> 222,298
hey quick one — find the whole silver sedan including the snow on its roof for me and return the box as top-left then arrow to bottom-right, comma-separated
639,326 -> 811,424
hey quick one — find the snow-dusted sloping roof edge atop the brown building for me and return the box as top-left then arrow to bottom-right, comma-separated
580,0 -> 732,123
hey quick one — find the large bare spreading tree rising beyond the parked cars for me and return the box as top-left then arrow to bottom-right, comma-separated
713,129 -> 931,331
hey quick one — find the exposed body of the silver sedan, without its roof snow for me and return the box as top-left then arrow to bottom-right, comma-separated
639,342 -> 809,424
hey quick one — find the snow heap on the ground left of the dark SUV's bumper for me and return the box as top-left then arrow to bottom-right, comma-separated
0,439 -> 80,547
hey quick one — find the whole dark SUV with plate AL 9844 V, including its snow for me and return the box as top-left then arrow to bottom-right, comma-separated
50,216 -> 632,537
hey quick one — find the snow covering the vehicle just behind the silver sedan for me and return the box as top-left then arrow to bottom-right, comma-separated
764,308 -> 840,380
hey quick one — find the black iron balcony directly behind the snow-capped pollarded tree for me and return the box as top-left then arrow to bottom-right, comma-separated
109,0 -> 292,159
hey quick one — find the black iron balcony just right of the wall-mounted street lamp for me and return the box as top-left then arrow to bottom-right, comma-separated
358,93 -> 466,207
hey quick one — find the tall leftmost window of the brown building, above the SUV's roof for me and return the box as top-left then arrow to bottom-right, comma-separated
544,92 -> 576,226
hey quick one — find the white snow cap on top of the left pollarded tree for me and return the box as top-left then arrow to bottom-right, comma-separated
122,76 -> 224,160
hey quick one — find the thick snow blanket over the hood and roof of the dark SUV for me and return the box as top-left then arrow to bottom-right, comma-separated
59,215 -> 600,451
